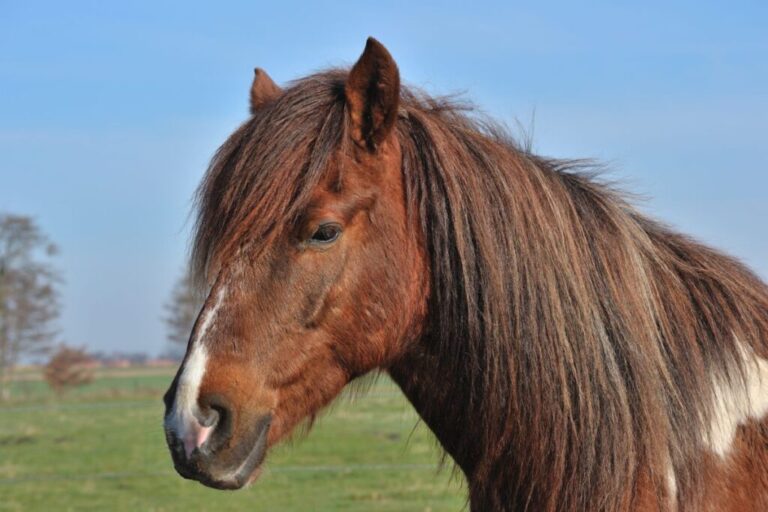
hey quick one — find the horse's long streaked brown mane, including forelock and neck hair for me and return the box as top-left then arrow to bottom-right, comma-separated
193,70 -> 768,510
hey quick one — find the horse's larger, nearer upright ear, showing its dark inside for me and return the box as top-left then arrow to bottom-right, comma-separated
344,37 -> 400,151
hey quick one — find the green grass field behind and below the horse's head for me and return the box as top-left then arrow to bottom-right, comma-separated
0,369 -> 465,512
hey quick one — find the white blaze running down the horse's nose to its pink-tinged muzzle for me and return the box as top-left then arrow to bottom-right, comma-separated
165,287 -> 226,457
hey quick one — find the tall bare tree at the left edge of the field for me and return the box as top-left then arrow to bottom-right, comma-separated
0,214 -> 61,400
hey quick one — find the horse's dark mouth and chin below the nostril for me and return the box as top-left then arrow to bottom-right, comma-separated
168,415 -> 272,490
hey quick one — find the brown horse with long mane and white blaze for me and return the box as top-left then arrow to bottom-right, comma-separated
165,39 -> 768,512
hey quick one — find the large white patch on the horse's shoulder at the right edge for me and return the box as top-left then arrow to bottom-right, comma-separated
704,340 -> 768,458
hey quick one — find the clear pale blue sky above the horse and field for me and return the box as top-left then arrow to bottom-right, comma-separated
0,0 -> 768,353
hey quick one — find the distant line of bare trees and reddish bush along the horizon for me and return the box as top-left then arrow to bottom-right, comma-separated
0,212 -> 198,401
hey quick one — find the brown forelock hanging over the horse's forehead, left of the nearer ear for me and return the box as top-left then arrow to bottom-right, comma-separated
192,71 -> 344,283
